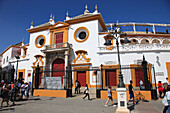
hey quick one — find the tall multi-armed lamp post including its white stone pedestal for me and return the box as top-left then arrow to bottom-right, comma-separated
104,24 -> 130,113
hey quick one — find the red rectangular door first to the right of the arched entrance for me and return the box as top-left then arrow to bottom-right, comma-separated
77,71 -> 86,86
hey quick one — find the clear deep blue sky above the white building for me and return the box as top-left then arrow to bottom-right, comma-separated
0,0 -> 170,53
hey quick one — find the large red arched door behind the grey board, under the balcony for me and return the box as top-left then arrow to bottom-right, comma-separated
52,58 -> 65,84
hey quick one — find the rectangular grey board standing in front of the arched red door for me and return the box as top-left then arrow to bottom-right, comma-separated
46,77 -> 62,89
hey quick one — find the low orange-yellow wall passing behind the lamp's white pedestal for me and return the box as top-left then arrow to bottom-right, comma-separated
101,90 -> 152,100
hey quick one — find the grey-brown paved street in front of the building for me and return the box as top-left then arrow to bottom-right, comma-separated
0,97 -> 163,113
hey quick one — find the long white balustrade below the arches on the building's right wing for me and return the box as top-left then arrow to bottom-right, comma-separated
97,44 -> 170,54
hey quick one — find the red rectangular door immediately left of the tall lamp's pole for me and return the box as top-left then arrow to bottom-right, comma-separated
105,70 -> 117,86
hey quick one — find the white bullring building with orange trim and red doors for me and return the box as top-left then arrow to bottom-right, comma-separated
1,6 -> 170,97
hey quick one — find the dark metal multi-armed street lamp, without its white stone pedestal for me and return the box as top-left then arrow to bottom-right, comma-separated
104,24 -> 130,87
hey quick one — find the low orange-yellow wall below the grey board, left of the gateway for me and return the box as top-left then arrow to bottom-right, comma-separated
33,89 -> 67,98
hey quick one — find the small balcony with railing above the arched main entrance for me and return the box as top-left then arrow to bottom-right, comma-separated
42,43 -> 72,52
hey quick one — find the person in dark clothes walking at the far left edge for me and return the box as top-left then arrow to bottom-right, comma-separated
1,85 -> 10,107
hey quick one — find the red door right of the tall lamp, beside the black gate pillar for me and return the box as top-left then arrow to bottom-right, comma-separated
135,68 -> 145,86
